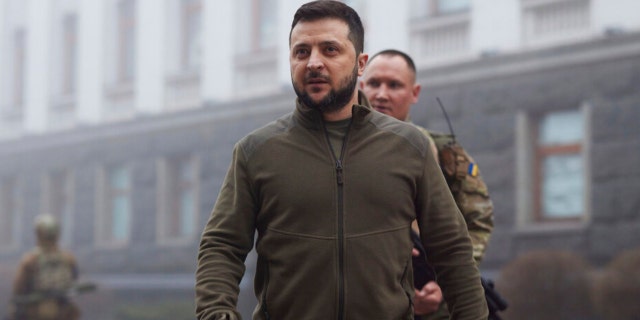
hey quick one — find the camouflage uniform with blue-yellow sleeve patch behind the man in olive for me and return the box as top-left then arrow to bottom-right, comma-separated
416,125 -> 493,320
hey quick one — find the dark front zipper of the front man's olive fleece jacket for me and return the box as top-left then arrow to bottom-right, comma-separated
322,119 -> 353,320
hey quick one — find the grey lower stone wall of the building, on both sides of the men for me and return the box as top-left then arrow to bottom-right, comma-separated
0,29 -> 640,273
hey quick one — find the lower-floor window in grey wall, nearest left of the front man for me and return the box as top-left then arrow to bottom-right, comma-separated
158,156 -> 198,242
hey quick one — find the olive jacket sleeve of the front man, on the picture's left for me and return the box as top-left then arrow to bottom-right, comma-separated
195,144 -> 256,320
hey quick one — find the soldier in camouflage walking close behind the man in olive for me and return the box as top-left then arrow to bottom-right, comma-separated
360,50 -> 493,320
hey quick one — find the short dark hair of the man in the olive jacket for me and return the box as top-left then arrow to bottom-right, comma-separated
289,0 -> 364,54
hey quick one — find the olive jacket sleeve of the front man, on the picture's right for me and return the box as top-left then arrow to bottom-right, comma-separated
416,146 -> 489,320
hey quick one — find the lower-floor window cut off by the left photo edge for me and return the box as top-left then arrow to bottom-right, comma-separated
0,178 -> 21,249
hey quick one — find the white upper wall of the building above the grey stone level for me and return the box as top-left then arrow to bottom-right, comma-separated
5,0 -> 640,139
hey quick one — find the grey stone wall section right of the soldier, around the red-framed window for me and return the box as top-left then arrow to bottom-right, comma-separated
412,34 -> 640,269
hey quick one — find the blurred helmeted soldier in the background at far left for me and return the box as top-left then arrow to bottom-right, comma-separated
10,214 -> 79,320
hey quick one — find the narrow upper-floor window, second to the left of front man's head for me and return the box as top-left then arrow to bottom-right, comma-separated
181,0 -> 202,70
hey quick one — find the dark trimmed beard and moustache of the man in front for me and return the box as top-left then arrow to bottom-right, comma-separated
293,64 -> 358,113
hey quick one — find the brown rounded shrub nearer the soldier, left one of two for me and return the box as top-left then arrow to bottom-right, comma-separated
496,250 -> 593,320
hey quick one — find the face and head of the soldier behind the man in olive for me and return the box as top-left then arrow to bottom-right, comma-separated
360,55 -> 420,121
